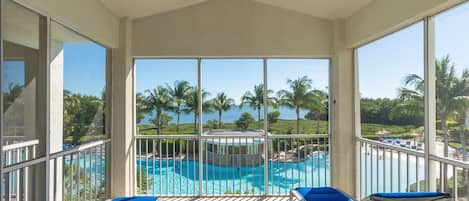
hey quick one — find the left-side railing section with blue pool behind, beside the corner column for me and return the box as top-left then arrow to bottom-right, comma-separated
50,139 -> 111,201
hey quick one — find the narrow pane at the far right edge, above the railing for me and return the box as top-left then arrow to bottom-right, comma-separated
435,3 -> 469,161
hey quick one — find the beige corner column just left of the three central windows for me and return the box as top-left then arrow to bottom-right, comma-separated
110,18 -> 135,197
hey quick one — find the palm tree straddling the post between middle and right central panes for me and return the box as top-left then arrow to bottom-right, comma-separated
240,84 -> 274,129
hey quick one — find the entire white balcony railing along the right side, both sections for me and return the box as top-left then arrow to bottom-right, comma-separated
358,138 -> 469,200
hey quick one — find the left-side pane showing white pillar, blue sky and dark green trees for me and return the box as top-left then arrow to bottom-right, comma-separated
50,22 -> 106,152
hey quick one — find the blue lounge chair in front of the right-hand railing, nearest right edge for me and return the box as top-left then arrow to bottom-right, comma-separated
364,192 -> 452,201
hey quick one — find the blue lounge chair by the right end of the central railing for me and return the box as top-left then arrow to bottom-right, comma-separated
290,187 -> 353,201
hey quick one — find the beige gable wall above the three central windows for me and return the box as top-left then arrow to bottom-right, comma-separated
132,0 -> 332,57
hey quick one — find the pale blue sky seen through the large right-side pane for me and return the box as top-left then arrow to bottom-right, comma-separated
358,23 -> 424,98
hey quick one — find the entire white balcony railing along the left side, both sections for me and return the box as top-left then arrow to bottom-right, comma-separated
1,140 -> 110,201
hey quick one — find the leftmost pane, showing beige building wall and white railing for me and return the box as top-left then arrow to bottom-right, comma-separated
2,1 -> 46,160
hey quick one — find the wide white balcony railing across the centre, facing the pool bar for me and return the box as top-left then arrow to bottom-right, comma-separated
135,134 -> 330,197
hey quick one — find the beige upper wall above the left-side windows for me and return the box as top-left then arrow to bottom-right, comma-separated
14,0 -> 119,48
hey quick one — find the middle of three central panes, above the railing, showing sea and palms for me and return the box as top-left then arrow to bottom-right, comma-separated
202,59 -> 264,131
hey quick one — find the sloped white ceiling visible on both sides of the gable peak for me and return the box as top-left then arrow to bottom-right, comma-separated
100,0 -> 373,19
